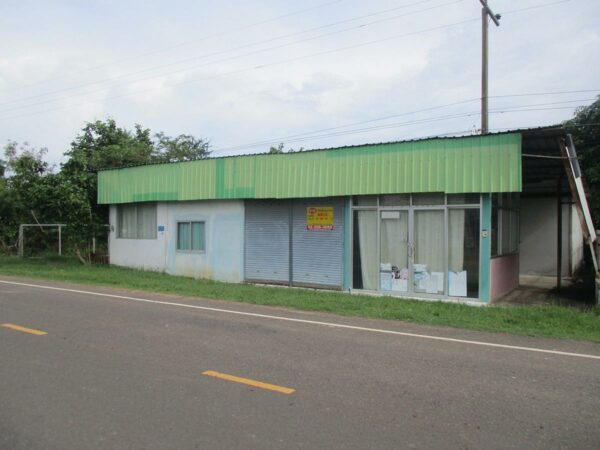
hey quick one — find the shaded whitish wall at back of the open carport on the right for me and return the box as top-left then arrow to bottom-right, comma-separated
519,197 -> 583,277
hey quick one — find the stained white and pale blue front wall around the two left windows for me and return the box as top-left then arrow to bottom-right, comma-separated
109,201 -> 244,282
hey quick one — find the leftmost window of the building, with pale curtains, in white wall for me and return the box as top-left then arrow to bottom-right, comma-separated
117,203 -> 156,239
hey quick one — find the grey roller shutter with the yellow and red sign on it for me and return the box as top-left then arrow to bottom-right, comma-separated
292,198 -> 344,288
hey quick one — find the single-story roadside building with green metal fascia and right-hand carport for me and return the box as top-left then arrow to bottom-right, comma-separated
98,127 -> 595,302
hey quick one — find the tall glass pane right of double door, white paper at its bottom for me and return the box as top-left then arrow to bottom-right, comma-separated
448,209 -> 479,298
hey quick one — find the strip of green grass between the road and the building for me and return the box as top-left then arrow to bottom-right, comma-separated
0,256 -> 600,342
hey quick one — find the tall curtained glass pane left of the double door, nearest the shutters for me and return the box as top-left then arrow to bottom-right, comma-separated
352,211 -> 378,291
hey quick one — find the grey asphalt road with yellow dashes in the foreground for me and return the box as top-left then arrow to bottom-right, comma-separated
0,278 -> 600,449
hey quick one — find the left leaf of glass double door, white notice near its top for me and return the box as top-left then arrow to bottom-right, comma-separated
379,210 -> 410,292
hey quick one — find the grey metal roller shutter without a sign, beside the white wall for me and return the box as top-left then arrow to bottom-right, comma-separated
244,201 -> 290,283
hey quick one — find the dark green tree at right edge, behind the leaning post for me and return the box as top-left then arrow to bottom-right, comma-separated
565,97 -> 600,224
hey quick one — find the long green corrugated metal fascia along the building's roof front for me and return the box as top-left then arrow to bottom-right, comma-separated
98,133 -> 521,204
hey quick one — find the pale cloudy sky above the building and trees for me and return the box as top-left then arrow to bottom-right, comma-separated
0,0 -> 600,165
